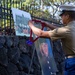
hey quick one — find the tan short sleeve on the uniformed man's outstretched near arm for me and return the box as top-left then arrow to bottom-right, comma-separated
49,27 -> 69,40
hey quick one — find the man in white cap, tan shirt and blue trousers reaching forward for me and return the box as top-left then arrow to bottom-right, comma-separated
29,5 -> 75,75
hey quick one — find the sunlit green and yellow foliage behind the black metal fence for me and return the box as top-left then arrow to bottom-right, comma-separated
0,0 -> 75,25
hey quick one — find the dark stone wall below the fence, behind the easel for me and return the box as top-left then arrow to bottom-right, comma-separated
0,36 -> 64,75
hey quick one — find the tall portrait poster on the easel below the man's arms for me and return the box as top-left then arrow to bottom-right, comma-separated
34,24 -> 58,75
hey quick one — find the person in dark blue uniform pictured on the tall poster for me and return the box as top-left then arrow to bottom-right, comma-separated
39,42 -> 58,75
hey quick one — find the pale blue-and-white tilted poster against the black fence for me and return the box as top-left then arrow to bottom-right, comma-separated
12,8 -> 31,37
